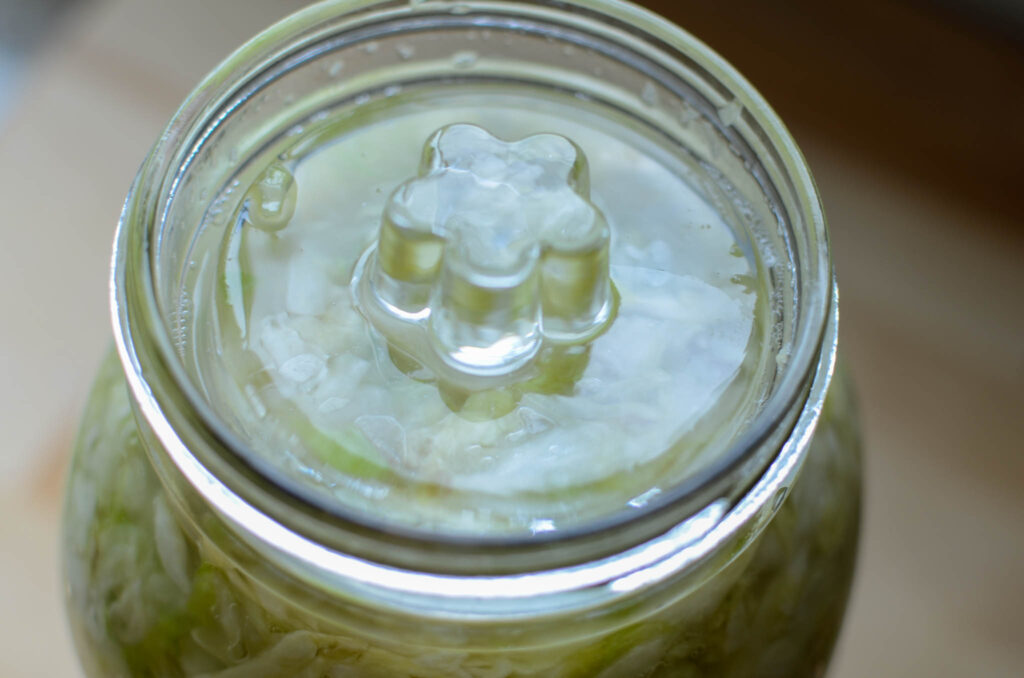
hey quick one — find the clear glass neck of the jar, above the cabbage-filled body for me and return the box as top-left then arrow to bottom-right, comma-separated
112,0 -> 836,620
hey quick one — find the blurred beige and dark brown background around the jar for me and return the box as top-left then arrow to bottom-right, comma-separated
0,0 -> 1024,678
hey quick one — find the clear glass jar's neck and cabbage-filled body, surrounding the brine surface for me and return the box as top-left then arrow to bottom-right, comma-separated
63,0 -> 860,678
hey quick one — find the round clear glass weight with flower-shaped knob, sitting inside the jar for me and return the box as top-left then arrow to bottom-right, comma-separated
192,87 -> 769,537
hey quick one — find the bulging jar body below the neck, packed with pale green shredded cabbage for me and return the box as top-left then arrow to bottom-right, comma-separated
63,355 -> 860,678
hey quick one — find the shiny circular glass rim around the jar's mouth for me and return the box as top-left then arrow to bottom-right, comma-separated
111,0 -> 836,595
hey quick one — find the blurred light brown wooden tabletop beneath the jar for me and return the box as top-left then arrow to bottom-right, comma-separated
0,0 -> 1024,678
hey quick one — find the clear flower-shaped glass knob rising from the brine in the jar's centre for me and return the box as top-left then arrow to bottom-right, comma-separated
358,124 -> 613,376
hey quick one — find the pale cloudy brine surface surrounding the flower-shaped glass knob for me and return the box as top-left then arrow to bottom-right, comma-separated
193,89 -> 764,534
